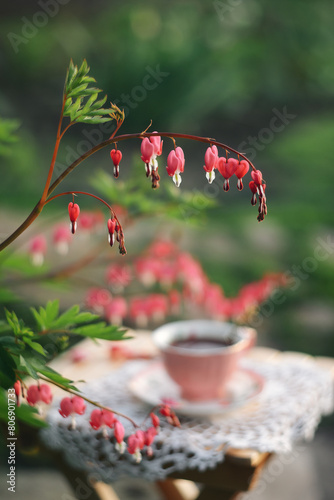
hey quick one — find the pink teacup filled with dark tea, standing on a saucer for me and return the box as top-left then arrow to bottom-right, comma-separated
153,320 -> 256,401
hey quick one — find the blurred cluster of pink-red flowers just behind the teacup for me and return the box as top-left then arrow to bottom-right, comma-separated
85,240 -> 284,328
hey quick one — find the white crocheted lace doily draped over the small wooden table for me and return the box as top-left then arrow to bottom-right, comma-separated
41,358 -> 334,483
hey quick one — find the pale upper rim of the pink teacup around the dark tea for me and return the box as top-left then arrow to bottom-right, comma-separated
152,319 -> 256,357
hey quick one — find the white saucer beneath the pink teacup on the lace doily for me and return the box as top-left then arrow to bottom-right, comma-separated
129,361 -> 265,416
